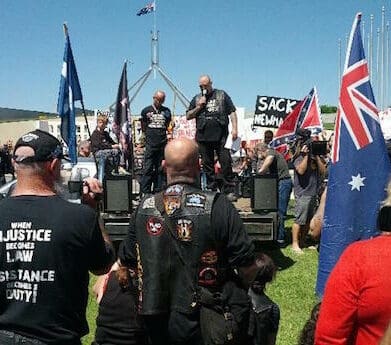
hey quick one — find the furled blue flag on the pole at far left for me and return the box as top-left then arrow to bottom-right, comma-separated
57,28 -> 83,163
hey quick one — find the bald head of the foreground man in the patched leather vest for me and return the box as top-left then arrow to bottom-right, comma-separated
164,138 -> 199,184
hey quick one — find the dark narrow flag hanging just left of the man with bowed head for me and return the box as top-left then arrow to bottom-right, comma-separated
113,62 -> 133,169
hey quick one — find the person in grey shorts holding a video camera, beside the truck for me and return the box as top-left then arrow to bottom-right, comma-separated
292,139 -> 326,254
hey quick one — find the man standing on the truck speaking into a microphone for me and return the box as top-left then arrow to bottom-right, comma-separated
186,75 -> 238,201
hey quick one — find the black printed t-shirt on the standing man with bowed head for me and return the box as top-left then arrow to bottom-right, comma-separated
141,105 -> 171,148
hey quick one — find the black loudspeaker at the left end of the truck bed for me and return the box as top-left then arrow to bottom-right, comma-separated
103,174 -> 132,214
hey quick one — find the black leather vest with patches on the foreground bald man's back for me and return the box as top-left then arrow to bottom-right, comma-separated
136,184 -> 223,315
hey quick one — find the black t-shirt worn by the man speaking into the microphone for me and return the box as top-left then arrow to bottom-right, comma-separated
188,89 -> 236,142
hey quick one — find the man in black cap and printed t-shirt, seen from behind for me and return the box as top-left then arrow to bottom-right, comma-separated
0,130 -> 113,345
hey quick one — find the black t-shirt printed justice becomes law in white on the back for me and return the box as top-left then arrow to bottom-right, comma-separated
0,196 -> 113,345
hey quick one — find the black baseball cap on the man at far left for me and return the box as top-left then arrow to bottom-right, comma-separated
13,129 -> 64,163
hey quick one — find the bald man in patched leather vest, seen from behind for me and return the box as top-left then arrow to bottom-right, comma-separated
119,138 -> 253,345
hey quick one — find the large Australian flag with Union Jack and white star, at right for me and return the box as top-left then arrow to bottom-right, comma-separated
316,13 -> 391,295
